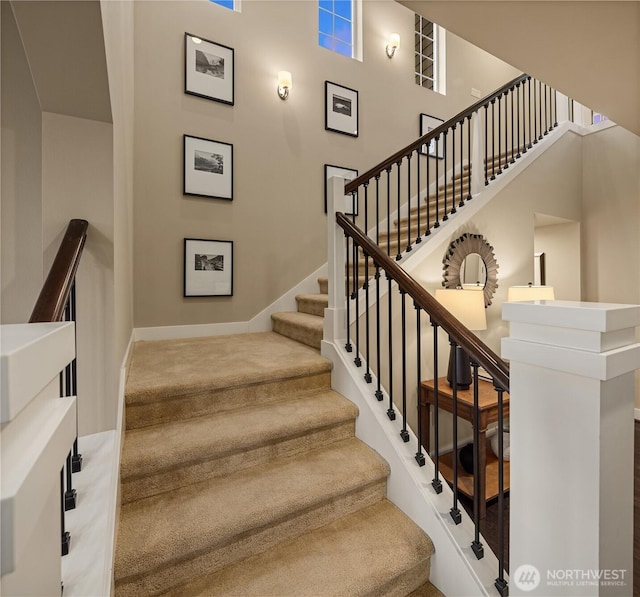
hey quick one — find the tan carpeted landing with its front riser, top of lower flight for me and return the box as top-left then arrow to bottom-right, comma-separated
125,330 -> 331,429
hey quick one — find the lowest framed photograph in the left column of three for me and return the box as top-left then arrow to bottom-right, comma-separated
184,238 -> 233,297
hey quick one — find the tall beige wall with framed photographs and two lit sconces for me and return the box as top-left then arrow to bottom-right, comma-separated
134,0 -> 518,327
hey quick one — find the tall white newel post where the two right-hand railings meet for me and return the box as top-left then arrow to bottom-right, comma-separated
323,176 -> 351,342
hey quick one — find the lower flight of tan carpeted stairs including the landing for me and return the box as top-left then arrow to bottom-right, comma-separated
115,326 -> 441,597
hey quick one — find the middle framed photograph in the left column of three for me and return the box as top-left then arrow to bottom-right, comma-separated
183,135 -> 233,200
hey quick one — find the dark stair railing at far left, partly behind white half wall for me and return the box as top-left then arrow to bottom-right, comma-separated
29,219 -> 89,556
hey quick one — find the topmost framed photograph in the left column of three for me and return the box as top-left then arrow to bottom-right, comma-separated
184,33 -> 234,105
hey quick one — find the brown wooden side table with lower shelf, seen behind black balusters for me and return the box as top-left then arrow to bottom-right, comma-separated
420,377 -> 509,518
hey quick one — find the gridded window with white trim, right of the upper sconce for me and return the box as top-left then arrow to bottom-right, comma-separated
415,14 -> 444,93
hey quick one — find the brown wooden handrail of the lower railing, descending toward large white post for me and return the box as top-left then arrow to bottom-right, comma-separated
336,212 -> 509,392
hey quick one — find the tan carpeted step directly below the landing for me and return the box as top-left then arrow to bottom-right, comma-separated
120,389 -> 358,504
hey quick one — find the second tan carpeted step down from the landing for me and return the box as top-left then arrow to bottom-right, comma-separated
115,438 -> 389,597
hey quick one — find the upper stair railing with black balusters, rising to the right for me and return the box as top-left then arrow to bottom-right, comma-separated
345,74 -> 558,260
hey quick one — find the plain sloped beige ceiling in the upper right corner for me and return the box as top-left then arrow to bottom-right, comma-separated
397,0 -> 640,135
